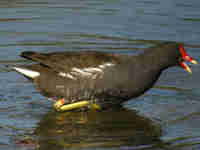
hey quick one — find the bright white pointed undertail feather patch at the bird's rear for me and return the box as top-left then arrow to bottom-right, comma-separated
13,67 -> 40,79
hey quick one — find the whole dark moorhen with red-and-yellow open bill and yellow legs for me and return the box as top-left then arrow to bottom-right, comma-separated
12,42 -> 197,111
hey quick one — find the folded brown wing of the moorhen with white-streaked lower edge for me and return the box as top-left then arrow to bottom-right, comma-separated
21,51 -> 119,79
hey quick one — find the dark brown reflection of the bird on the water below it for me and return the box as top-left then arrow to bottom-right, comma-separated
35,110 -> 161,150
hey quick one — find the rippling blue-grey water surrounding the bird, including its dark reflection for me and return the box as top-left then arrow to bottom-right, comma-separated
0,0 -> 200,150
